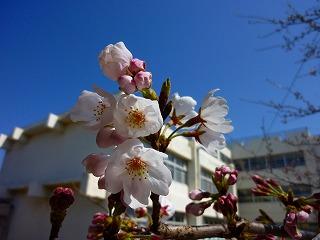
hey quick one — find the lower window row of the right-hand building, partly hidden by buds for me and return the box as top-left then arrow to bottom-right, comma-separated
238,185 -> 311,203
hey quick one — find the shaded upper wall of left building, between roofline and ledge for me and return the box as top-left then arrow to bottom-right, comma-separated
0,125 -> 101,186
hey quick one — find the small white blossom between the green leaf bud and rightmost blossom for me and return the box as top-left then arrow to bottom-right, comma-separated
171,93 -> 198,124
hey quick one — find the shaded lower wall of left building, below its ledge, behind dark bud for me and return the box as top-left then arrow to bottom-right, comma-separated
8,194 -> 103,240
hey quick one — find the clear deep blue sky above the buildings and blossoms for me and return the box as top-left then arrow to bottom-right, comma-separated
0,0 -> 320,150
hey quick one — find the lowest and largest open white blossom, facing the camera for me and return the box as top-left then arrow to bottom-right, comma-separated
104,139 -> 172,208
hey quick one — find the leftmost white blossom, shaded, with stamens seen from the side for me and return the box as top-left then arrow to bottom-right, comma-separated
70,90 -> 116,129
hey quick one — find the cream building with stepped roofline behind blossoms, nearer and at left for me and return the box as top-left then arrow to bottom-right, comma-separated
0,114 -> 231,240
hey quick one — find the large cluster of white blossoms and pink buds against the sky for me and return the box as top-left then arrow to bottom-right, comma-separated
70,42 -> 232,211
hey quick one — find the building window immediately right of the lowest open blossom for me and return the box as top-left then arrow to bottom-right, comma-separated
164,155 -> 188,183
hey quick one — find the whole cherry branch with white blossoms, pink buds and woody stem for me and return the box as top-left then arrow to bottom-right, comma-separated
63,42 -> 320,240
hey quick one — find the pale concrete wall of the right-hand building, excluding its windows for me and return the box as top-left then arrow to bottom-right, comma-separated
230,131 -> 320,222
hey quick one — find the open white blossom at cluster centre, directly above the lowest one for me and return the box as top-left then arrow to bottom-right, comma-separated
114,94 -> 163,137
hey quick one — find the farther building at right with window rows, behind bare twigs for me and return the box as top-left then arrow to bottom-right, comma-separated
229,129 -> 320,223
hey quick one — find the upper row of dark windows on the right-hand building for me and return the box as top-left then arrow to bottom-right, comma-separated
235,151 -> 305,171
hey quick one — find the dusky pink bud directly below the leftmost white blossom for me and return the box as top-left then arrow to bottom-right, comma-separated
96,128 -> 127,148
